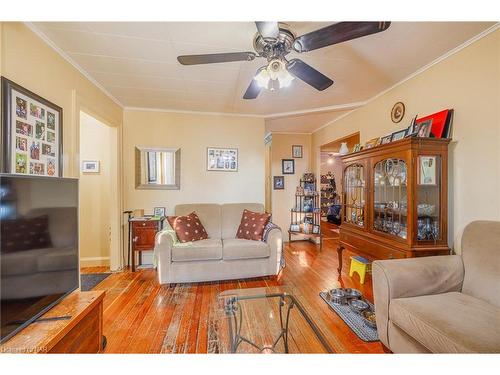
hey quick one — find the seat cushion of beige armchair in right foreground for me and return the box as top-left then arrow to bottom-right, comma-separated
389,292 -> 500,353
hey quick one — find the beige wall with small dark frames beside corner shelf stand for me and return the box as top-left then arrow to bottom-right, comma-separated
271,133 -> 311,241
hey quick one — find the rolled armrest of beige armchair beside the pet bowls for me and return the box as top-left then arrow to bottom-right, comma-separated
372,255 -> 464,348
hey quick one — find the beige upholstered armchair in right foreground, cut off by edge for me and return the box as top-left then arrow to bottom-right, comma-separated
372,221 -> 500,353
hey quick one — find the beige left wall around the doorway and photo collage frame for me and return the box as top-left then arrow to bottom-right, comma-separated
0,22 -> 123,269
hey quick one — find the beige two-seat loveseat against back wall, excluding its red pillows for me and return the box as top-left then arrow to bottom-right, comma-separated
155,203 -> 282,284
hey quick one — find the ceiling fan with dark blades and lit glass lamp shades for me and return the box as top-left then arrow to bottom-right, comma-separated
177,21 -> 391,99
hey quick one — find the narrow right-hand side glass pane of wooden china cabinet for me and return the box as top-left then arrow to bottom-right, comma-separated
416,155 -> 441,241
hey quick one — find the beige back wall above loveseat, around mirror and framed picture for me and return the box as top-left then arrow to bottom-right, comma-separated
123,110 -> 264,214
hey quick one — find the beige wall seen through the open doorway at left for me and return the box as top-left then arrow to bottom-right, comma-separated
80,112 -> 116,266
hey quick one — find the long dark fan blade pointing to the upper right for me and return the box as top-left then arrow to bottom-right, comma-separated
293,22 -> 391,52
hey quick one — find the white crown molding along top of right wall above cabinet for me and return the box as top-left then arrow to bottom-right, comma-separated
313,22 -> 500,134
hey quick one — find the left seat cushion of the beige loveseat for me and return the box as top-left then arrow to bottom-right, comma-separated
172,238 -> 222,262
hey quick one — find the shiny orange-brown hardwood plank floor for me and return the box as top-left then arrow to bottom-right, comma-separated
82,223 -> 383,353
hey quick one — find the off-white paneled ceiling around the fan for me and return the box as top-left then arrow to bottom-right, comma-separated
32,22 -> 493,132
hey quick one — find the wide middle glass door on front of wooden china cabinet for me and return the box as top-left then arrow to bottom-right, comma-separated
373,158 -> 408,239
